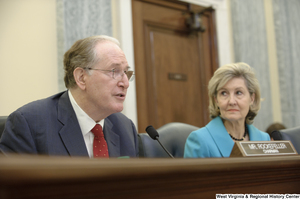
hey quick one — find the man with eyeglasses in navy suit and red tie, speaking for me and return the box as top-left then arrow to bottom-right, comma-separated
0,35 -> 138,158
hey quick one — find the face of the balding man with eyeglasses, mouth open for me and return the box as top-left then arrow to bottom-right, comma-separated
85,42 -> 129,116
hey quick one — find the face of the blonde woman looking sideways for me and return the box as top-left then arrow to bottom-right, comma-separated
215,77 -> 255,122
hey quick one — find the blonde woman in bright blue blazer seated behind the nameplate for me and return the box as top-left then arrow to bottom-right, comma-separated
184,63 -> 270,158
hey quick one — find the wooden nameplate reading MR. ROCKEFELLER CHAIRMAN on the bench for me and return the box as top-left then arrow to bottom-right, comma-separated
230,140 -> 298,157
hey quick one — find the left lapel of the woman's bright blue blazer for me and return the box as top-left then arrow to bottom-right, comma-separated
206,117 -> 234,157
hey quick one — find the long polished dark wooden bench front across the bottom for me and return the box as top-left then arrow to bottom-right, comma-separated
0,155 -> 300,199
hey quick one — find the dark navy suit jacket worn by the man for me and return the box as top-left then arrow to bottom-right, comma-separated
0,91 -> 138,157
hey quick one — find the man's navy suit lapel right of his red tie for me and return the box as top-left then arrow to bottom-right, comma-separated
103,118 -> 121,157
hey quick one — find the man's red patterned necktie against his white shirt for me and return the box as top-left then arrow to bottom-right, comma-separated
91,124 -> 109,158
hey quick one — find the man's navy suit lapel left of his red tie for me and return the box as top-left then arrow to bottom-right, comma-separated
58,92 -> 88,156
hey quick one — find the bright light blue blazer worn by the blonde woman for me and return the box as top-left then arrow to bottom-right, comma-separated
184,117 -> 270,158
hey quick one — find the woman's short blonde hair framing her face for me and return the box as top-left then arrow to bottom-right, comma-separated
208,62 -> 260,124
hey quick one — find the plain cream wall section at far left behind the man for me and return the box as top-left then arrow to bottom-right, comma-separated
0,0 -> 58,115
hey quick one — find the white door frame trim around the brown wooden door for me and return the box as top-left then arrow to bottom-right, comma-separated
111,0 -> 234,133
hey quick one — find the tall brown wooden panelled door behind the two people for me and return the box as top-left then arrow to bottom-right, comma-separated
132,0 -> 218,132
